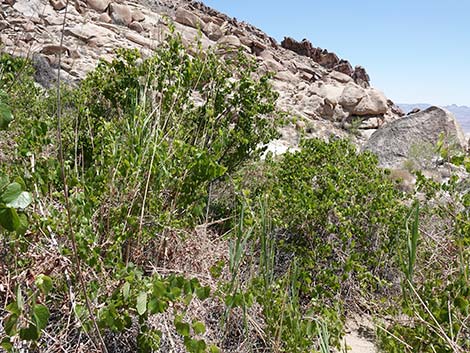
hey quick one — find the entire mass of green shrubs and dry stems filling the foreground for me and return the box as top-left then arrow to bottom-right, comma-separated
0,33 -> 470,353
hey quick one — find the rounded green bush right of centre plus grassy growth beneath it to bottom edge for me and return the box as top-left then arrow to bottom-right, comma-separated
246,139 -> 408,352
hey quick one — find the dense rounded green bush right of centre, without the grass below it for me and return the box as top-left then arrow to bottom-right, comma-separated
272,139 -> 407,298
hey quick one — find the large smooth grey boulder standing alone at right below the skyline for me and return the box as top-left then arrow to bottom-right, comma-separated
364,107 -> 467,169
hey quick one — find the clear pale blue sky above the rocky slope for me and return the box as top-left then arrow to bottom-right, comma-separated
203,0 -> 470,106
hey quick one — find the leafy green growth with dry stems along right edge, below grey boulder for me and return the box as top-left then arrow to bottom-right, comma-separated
379,173 -> 470,353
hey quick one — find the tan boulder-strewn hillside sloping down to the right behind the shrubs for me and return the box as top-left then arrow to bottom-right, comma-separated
0,0 -> 402,145
